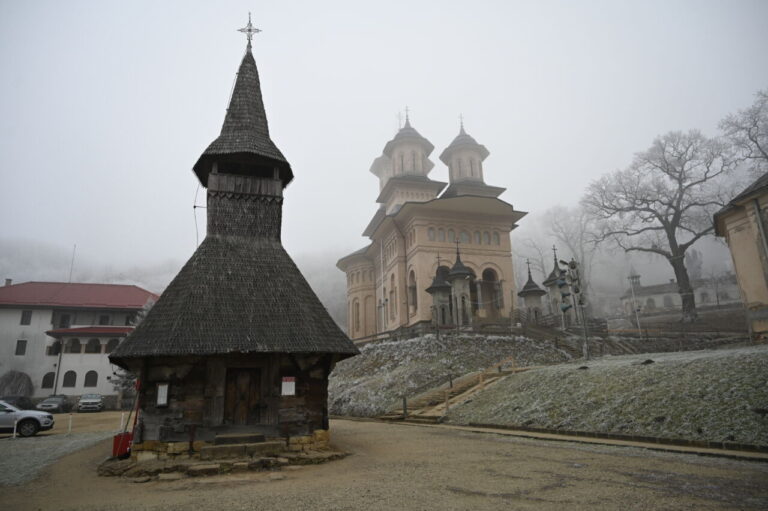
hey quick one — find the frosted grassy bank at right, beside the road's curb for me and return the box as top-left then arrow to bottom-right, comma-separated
447,345 -> 768,445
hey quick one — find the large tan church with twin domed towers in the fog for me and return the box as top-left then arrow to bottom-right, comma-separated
337,117 -> 526,339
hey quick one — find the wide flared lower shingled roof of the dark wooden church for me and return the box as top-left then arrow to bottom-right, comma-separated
110,236 -> 358,364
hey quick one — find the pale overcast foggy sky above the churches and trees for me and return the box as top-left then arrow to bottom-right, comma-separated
0,0 -> 768,288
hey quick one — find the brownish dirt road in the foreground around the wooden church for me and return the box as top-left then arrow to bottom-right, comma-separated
3,420 -> 768,510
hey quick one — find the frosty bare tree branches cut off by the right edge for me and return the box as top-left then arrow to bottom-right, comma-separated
720,89 -> 768,177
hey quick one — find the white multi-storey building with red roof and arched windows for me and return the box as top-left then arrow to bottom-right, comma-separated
0,279 -> 159,402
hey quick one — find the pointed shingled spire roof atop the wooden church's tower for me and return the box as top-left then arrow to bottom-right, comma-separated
194,46 -> 293,186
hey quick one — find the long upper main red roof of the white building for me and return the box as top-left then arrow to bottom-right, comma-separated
0,282 -> 158,309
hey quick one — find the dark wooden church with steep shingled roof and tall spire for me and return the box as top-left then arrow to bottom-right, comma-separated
109,21 -> 358,443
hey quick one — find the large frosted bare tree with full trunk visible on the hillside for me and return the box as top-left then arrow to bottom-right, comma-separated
582,130 -> 735,321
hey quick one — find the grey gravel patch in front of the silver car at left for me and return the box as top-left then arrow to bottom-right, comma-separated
0,432 -> 114,486
